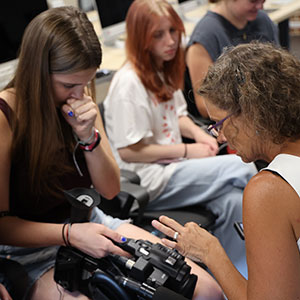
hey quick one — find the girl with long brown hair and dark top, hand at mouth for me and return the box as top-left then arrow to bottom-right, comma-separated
0,7 -> 223,300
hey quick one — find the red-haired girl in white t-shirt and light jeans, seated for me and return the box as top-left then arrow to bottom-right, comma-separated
104,0 -> 257,280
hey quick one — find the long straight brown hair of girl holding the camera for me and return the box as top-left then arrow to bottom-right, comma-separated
7,7 -> 102,197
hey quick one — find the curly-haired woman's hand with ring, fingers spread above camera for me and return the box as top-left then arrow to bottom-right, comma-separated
152,216 -> 219,264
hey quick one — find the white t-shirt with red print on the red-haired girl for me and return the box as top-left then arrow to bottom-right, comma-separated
104,63 -> 187,201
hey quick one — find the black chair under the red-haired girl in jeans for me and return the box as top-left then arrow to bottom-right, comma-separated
99,102 -> 217,236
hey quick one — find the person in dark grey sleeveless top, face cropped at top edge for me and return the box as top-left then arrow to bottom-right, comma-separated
184,0 -> 279,123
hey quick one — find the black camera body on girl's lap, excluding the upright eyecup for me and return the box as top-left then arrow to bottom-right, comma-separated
54,239 -> 197,299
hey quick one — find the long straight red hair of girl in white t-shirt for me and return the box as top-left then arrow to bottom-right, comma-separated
126,0 -> 185,101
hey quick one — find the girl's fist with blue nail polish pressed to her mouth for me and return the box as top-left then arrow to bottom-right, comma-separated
62,95 -> 98,141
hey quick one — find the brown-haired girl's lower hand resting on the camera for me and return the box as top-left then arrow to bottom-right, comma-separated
69,223 -> 129,258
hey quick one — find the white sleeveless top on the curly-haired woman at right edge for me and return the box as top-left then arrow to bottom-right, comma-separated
263,154 -> 300,251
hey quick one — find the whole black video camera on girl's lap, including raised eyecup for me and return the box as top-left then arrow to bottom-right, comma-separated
54,188 -> 197,300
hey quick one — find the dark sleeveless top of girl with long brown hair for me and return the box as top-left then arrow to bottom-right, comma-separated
0,98 -> 92,223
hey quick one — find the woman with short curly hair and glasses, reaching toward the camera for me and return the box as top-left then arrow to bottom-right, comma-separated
153,43 -> 300,300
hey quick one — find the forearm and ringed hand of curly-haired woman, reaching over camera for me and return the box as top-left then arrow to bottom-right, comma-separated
152,216 -> 248,300
